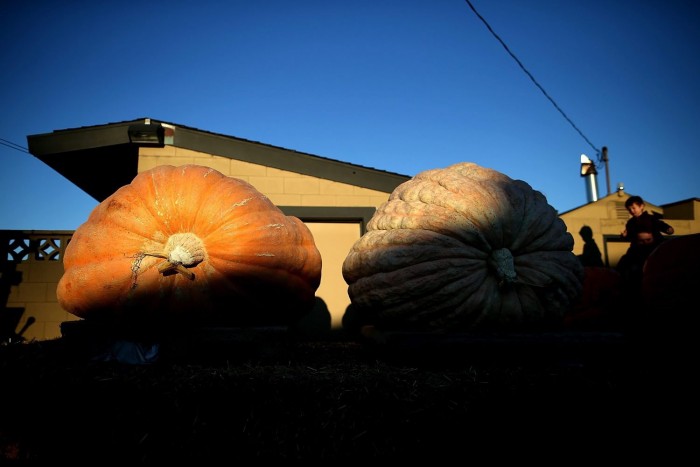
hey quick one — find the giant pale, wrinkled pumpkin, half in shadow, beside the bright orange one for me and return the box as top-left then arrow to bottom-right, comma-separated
343,162 -> 583,330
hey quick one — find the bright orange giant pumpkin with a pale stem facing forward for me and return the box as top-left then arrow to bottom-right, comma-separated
57,165 -> 321,324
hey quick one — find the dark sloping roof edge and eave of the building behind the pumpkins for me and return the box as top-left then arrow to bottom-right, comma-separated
27,118 -> 411,202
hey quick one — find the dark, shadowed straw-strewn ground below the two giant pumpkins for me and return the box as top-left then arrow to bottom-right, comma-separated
0,328 -> 696,465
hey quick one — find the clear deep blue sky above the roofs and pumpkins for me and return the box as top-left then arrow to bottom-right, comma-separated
0,0 -> 700,230
